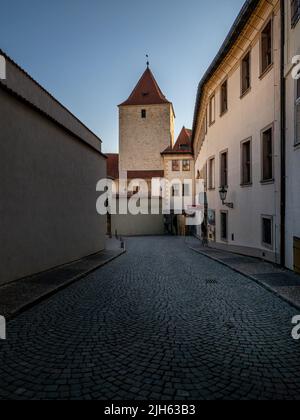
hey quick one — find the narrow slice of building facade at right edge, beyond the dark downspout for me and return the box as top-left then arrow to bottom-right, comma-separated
284,0 -> 300,272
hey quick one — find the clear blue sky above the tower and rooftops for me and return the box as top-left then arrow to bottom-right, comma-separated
0,0 -> 244,152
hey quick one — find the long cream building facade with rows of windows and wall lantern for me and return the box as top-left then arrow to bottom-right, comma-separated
193,0 -> 281,263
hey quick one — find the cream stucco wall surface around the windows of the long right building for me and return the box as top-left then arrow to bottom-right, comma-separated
195,1 -> 281,262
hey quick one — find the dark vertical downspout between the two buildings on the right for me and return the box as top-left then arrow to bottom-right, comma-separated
280,0 -> 286,267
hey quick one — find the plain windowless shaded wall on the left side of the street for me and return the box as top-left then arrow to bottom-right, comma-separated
0,86 -> 106,284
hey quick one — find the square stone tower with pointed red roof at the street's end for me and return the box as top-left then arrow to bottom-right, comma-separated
119,67 -> 175,180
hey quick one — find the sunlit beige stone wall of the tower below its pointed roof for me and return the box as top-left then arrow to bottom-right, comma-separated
119,104 -> 174,177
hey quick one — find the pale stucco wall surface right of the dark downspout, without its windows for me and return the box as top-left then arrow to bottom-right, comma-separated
285,2 -> 300,270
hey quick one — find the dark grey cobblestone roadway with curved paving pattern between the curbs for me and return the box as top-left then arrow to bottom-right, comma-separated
0,237 -> 300,400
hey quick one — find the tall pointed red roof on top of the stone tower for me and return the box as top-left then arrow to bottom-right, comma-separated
119,67 -> 171,106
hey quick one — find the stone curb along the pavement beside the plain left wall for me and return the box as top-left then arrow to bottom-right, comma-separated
5,248 -> 126,321
